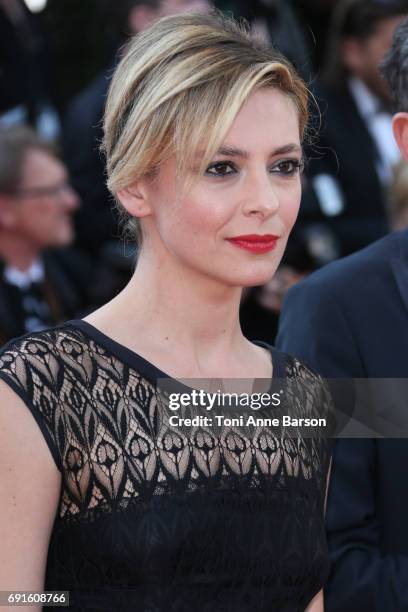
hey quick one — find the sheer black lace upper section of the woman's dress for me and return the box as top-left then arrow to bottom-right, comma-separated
0,325 -> 331,523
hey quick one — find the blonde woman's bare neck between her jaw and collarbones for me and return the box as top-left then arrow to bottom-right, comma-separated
118,246 -> 242,348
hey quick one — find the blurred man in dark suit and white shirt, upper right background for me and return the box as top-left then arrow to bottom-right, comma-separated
300,0 -> 408,259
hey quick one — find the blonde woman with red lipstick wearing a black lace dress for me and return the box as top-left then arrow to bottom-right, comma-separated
0,10 -> 330,612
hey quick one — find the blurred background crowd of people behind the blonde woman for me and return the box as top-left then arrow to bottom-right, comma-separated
0,0 -> 408,344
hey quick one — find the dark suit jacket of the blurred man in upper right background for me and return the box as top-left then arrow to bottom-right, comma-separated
300,85 -> 387,255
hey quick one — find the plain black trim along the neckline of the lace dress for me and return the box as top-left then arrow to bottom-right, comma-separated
65,319 -> 287,388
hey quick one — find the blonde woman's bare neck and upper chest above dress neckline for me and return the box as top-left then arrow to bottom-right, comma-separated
86,244 -> 259,377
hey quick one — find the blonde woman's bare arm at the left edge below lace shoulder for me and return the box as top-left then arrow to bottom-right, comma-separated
0,380 -> 61,612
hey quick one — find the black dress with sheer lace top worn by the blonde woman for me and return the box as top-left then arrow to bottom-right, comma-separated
0,321 -> 331,612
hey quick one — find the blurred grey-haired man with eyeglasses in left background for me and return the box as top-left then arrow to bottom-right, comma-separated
0,127 -> 91,345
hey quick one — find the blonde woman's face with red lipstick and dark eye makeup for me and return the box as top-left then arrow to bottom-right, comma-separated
135,88 -> 302,286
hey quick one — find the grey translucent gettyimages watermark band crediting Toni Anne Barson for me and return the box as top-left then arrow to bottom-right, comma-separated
157,377 -> 408,438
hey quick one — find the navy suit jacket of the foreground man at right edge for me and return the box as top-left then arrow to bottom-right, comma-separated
277,230 -> 408,612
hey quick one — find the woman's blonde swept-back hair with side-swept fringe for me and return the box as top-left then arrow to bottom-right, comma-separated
103,12 -> 308,240
